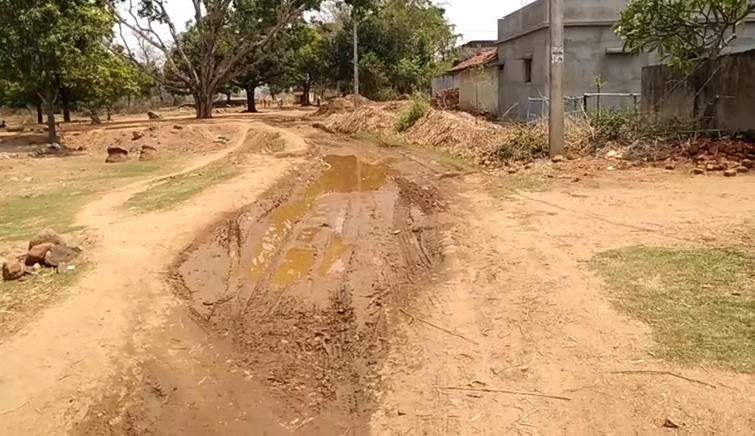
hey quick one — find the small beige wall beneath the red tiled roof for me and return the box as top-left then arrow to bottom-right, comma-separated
458,66 -> 498,114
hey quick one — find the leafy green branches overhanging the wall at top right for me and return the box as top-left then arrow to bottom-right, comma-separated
614,0 -> 755,70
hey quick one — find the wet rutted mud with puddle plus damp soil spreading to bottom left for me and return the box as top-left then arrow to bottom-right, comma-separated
78,135 -> 454,435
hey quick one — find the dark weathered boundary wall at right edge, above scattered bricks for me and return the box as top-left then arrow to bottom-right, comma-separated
642,50 -> 755,133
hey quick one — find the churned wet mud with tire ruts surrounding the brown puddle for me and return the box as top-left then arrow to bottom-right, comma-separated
168,140 -> 443,434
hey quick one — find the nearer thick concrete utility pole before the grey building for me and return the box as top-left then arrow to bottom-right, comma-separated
548,0 -> 564,157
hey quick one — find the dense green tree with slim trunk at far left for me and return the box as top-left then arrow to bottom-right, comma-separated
0,0 -> 112,144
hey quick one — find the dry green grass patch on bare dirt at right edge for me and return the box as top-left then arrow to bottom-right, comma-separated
591,246 -> 755,373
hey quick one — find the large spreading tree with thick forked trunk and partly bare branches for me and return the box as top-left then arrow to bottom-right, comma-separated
111,0 -> 318,118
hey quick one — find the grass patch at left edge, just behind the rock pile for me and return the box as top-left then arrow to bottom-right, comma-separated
0,188 -> 93,241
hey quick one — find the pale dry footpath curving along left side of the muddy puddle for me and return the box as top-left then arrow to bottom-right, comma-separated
0,123 -> 300,435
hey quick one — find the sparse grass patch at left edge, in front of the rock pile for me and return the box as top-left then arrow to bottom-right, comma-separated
0,262 -> 90,337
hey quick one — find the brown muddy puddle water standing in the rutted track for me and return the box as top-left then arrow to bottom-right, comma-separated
251,154 -> 390,281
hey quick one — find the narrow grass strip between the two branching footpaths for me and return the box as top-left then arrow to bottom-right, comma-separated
123,159 -> 239,212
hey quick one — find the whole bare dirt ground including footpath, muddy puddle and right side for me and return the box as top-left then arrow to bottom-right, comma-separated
0,107 -> 755,435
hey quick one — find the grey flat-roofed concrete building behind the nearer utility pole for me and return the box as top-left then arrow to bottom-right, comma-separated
497,0 -> 755,120
